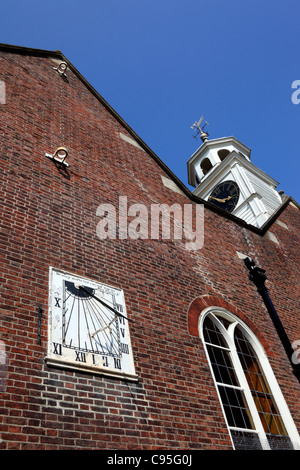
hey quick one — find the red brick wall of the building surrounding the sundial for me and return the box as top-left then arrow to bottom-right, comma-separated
0,52 -> 300,449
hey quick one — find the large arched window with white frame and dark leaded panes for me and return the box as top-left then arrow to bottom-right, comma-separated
201,309 -> 299,450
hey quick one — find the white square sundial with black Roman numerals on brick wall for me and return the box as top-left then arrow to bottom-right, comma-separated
46,268 -> 137,380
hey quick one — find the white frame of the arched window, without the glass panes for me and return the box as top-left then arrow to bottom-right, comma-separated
199,307 -> 300,450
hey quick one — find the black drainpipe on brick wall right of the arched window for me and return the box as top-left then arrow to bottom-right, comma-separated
244,258 -> 300,382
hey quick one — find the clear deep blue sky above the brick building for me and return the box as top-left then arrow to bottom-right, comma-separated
0,0 -> 300,203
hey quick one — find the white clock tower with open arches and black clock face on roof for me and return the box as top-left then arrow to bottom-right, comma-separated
187,132 -> 282,227
